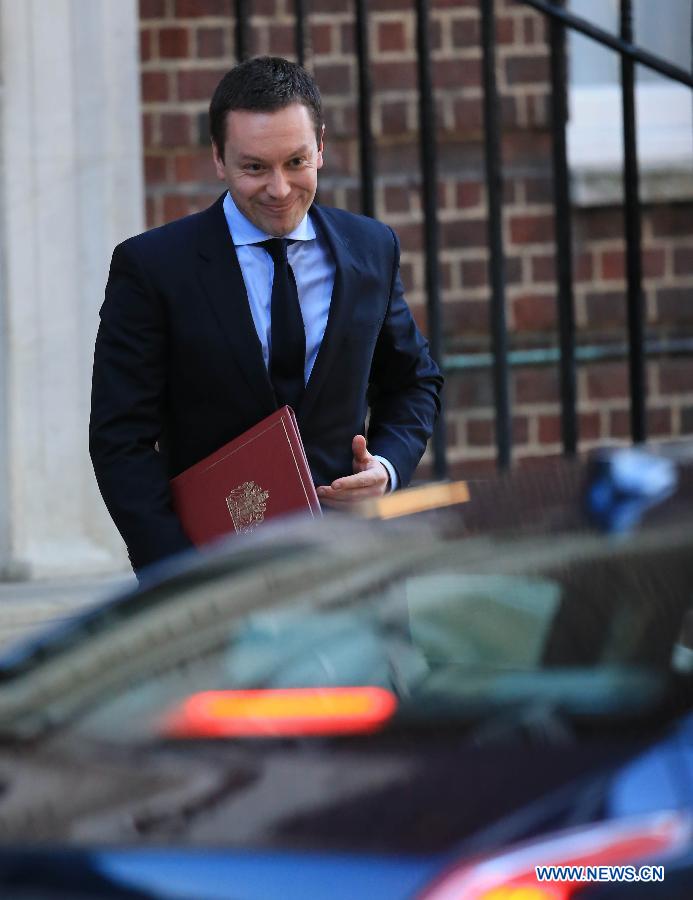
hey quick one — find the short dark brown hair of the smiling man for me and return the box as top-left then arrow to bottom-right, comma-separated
209,56 -> 322,160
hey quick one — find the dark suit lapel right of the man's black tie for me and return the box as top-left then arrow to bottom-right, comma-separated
298,206 -> 359,424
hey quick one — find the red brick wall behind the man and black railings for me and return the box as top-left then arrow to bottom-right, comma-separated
140,0 -> 693,474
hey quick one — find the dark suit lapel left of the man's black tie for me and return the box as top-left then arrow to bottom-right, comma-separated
198,195 -> 277,414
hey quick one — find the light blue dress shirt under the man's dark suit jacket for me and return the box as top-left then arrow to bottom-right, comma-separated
219,192 -> 398,490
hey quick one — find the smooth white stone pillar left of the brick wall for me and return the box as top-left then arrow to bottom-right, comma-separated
0,0 -> 143,577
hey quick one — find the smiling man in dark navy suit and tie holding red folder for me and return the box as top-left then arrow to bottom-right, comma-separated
90,57 -> 442,571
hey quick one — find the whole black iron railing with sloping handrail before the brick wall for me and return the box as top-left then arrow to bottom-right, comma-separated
234,0 -> 693,478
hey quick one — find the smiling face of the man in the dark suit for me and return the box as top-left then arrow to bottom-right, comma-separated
212,103 -> 323,237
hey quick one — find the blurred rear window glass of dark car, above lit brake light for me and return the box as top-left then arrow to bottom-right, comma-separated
67,516 -> 693,739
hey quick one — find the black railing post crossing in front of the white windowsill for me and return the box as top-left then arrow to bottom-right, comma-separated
620,0 -> 647,443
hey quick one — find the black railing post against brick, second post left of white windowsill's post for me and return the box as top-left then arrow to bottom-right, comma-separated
479,0 -> 511,469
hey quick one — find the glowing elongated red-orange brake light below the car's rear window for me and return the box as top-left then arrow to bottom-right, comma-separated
157,687 -> 397,738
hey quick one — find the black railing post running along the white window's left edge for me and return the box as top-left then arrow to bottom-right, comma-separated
550,0 -> 578,456
